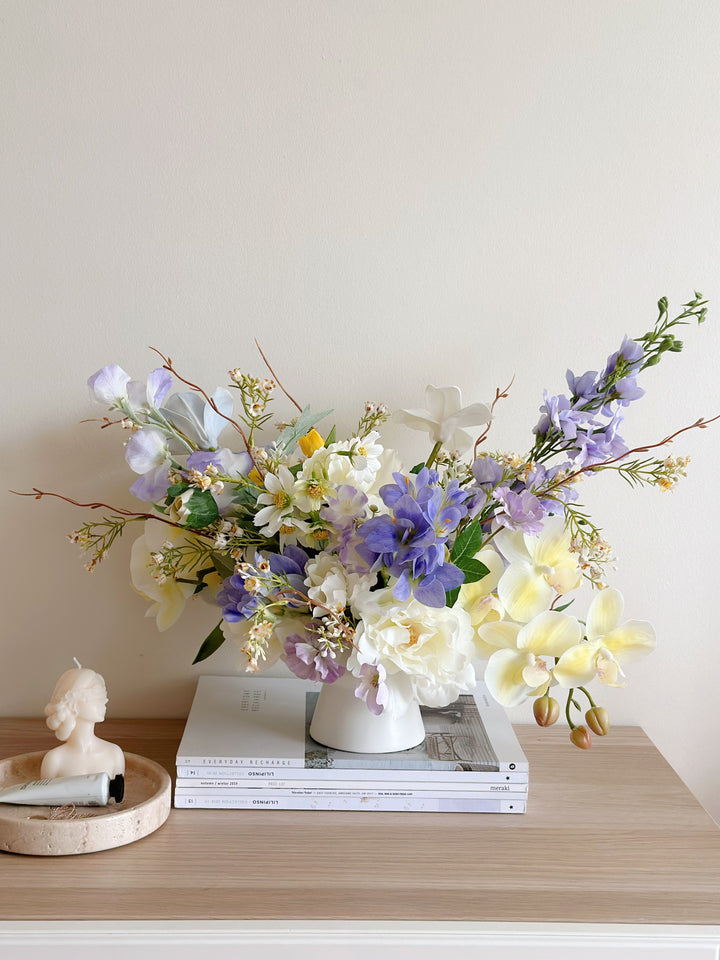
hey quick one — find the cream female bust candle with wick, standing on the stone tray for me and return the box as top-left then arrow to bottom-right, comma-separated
40,660 -> 125,779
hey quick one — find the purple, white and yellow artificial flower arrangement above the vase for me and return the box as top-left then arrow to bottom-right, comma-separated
19,294 -> 711,748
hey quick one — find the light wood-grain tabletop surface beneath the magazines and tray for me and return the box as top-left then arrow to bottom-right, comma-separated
0,719 -> 720,925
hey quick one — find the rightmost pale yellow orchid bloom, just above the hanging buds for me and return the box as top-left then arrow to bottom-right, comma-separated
553,588 -> 655,687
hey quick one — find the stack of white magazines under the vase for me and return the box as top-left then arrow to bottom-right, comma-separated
175,676 -> 528,813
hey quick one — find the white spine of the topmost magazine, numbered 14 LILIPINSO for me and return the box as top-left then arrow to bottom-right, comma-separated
175,765 -> 528,786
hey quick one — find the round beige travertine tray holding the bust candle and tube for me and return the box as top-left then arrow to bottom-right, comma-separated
0,751 -> 171,857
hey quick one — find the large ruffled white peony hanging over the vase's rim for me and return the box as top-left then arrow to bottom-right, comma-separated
348,589 -> 475,716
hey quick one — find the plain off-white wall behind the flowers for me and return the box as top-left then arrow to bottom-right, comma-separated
0,0 -> 720,817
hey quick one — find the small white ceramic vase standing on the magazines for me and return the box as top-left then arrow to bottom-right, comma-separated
310,672 -> 425,753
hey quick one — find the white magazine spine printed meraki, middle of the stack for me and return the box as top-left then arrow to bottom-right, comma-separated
175,777 -> 528,797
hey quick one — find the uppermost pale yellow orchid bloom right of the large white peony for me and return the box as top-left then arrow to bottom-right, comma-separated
495,517 -> 582,623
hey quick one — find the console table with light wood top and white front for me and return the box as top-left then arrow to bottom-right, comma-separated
0,719 -> 720,960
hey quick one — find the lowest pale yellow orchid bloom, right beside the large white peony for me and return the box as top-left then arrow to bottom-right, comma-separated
478,610 -> 582,707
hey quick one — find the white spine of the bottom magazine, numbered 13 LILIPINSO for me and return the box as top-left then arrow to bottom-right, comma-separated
175,793 -> 526,813
